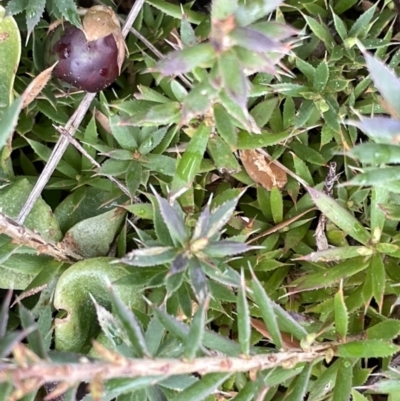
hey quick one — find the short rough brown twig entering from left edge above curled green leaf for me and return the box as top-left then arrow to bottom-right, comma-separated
0,213 -> 82,262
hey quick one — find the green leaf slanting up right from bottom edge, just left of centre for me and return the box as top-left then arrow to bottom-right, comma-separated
172,373 -> 231,401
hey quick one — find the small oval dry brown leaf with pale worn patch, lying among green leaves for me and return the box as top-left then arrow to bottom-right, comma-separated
240,149 -> 287,191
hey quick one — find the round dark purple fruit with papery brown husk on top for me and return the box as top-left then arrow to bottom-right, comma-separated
46,6 -> 125,92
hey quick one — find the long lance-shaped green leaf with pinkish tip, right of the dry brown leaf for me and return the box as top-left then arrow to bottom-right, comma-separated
307,188 -> 370,245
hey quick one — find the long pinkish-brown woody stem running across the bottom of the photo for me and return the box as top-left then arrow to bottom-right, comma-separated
0,343 -> 326,385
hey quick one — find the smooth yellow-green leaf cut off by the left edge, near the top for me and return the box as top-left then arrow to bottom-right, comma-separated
0,5 -> 22,111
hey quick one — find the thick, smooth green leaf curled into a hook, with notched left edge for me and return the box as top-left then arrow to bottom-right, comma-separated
54,258 -> 144,352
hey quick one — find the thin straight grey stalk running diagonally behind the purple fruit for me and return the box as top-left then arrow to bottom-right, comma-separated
17,0 -> 145,225
